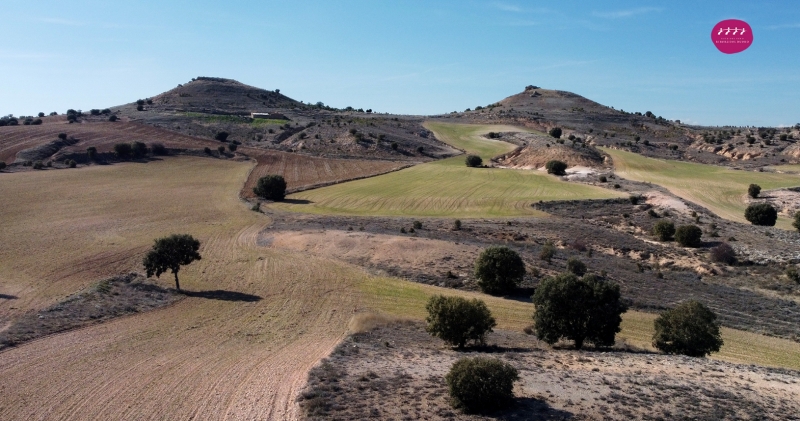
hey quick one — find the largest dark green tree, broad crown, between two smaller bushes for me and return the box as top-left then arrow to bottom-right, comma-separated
533,273 -> 628,349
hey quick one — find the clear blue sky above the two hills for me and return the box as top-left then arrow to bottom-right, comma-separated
0,0 -> 800,126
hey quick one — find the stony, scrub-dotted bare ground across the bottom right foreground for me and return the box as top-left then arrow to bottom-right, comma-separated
299,323 -> 800,420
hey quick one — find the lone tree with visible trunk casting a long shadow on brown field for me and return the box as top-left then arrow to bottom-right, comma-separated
144,234 -> 200,291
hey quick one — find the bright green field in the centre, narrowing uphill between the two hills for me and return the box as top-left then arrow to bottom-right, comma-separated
273,123 -> 622,218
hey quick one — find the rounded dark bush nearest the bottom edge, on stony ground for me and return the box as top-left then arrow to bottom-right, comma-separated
445,357 -> 519,412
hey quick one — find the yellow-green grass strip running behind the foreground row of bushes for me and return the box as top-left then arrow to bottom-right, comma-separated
359,278 -> 800,370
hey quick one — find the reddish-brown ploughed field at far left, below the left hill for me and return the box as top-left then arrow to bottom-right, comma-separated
0,121 -> 220,164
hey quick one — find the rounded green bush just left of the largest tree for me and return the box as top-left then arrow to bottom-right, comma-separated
425,295 -> 497,348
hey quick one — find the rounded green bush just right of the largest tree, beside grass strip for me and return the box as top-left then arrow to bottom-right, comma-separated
653,300 -> 723,357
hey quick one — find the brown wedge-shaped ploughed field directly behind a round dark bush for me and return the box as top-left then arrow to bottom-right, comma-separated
240,148 -> 408,197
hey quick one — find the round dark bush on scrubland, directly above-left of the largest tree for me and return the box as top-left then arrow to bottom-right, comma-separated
475,246 -> 525,295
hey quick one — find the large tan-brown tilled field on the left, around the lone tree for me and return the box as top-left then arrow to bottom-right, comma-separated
0,157 -> 382,420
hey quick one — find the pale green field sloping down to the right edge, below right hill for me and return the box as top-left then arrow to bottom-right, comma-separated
603,148 -> 800,229
